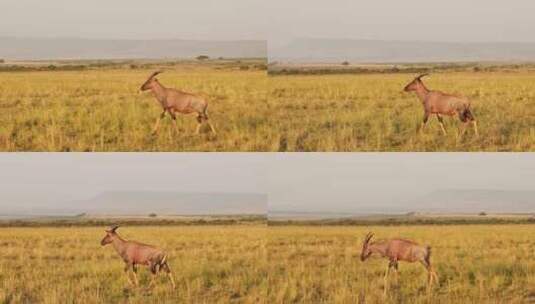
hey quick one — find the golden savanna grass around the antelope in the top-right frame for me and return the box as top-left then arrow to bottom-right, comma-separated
268,68 -> 535,151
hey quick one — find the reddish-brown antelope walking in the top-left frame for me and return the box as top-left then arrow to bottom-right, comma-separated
141,71 -> 216,134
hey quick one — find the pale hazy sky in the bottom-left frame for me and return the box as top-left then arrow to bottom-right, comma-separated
0,153 -> 265,208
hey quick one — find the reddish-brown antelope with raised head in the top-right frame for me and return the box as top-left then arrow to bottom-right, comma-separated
404,74 -> 479,136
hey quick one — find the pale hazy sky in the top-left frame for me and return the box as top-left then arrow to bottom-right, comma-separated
0,0 -> 268,40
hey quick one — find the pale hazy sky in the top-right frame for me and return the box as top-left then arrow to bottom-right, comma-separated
268,0 -> 535,46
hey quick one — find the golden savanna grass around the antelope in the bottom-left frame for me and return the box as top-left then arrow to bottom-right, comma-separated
0,225 -> 269,303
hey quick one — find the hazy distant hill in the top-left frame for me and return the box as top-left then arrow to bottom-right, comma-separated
0,37 -> 267,60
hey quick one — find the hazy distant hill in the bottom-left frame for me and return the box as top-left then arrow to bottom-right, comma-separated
2,191 -> 267,217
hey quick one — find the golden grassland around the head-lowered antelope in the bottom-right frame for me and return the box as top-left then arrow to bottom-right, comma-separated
267,225 -> 535,303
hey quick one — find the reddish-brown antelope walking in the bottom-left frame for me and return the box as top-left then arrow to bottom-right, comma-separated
100,226 -> 175,288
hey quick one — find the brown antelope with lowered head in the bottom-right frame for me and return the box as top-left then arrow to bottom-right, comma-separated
360,232 -> 438,294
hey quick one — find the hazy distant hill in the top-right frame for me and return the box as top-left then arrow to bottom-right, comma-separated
269,39 -> 535,63
